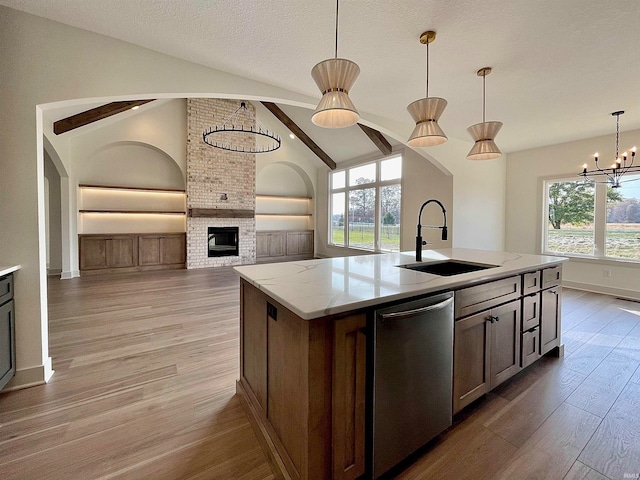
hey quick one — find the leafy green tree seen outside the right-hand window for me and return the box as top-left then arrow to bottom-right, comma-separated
549,181 -> 622,230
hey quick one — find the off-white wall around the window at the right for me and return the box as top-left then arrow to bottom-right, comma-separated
506,130 -> 640,298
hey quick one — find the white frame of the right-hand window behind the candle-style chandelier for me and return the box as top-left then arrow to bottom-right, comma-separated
540,175 -> 640,264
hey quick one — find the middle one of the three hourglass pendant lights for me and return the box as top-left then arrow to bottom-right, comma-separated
407,31 -> 447,147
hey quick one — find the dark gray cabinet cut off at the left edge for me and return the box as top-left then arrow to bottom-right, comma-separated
0,274 -> 16,388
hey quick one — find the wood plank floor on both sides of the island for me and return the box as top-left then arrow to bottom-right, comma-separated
0,268 -> 640,480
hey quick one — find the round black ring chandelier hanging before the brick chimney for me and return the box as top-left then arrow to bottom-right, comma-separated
202,102 -> 282,153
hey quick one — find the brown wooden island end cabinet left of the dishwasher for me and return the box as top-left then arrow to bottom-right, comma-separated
237,280 -> 366,480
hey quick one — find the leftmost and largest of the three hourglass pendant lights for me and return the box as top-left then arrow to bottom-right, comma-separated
311,0 -> 360,128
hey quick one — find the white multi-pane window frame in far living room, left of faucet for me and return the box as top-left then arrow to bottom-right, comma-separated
327,153 -> 403,253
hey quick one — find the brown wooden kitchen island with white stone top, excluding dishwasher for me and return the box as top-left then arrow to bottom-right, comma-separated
236,249 -> 566,479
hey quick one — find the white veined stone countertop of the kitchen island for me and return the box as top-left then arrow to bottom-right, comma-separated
234,248 -> 568,320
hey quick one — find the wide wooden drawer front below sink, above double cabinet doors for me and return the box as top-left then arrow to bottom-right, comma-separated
455,275 -> 521,318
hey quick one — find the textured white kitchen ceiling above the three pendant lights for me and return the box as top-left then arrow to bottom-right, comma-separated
7,0 -> 640,153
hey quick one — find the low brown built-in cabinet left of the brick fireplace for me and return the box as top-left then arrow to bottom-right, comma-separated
79,233 -> 186,274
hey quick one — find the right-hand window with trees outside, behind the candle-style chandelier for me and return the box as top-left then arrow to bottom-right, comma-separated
543,175 -> 640,261
